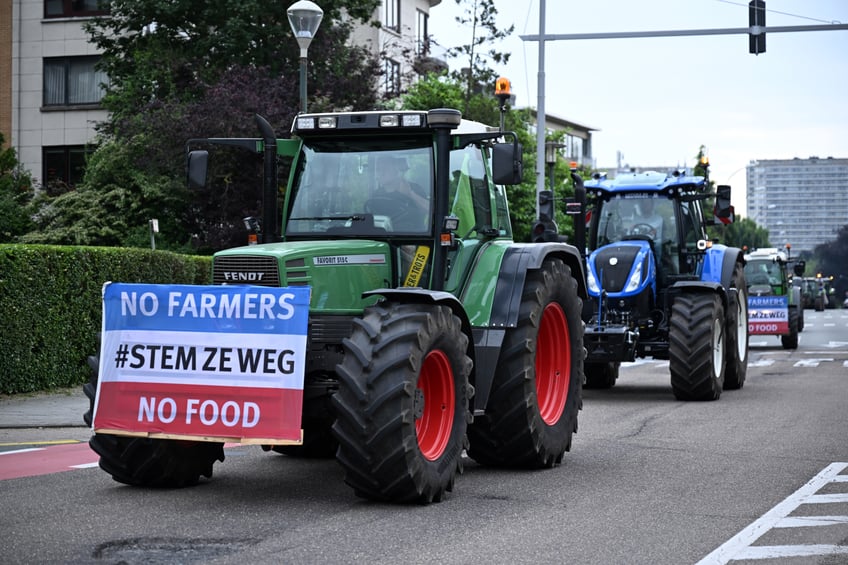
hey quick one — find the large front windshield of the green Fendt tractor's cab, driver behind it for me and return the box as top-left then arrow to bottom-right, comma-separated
285,138 -> 434,236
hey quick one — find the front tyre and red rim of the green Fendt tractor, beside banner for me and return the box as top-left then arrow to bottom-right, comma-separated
333,302 -> 473,503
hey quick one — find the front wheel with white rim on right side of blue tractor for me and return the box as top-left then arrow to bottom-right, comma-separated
668,292 -> 726,400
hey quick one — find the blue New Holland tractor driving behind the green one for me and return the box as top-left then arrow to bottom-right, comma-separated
572,165 -> 748,400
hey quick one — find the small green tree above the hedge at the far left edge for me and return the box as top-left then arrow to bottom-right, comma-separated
0,133 -> 34,243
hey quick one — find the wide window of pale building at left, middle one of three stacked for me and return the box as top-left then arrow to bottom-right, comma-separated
44,55 -> 108,106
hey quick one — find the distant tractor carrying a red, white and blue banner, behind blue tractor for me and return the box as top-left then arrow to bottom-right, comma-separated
745,247 -> 805,349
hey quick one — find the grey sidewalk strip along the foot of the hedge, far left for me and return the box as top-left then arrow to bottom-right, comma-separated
0,386 -> 88,428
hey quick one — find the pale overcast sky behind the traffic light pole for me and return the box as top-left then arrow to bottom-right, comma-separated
430,0 -> 848,214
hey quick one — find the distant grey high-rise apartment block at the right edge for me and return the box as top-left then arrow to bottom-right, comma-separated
746,157 -> 848,255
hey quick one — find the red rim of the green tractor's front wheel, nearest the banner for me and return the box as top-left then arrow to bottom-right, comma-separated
415,351 -> 456,461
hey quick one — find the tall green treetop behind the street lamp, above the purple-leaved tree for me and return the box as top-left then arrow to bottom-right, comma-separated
85,0 -> 380,125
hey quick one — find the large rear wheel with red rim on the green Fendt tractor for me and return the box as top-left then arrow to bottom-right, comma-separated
468,259 -> 583,468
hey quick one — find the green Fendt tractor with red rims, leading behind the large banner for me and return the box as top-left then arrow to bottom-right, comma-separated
85,109 -> 586,503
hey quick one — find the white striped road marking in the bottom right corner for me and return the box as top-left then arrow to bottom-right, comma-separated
696,462 -> 848,565
